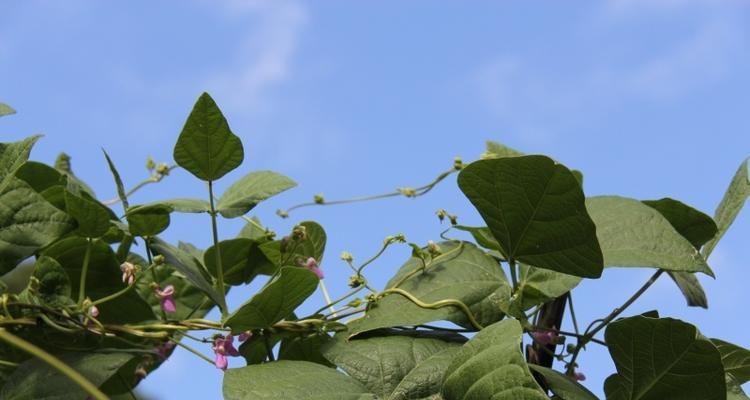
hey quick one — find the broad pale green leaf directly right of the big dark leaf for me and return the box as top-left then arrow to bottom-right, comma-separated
586,196 -> 713,276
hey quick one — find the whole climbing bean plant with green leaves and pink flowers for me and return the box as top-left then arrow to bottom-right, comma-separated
0,93 -> 750,400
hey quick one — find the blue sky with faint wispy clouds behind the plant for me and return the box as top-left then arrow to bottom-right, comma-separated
0,0 -> 750,399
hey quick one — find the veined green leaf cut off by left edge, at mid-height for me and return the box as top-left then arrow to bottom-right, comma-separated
0,178 -> 74,274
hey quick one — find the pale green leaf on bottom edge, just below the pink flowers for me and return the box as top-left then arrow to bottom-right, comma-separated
224,361 -> 375,400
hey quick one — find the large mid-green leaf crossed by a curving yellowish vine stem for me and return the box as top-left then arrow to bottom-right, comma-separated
350,242 -> 510,335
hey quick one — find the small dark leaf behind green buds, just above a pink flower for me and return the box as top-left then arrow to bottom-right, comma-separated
260,221 -> 327,267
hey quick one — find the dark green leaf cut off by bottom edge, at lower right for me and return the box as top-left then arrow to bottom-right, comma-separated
604,316 -> 726,400
